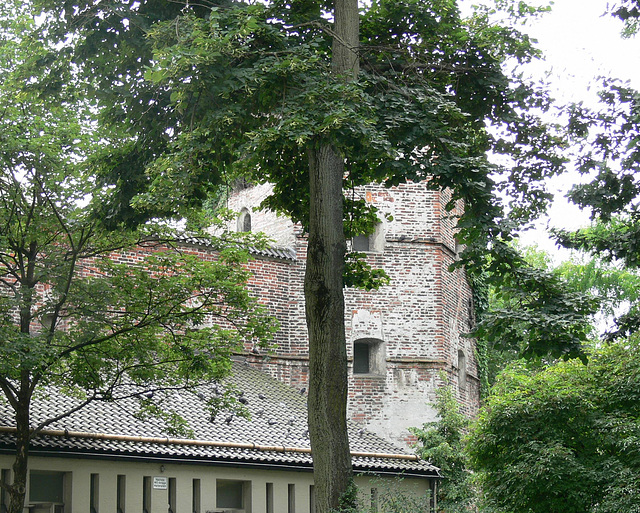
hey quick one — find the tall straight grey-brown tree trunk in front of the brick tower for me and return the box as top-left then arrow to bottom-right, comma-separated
304,0 -> 359,513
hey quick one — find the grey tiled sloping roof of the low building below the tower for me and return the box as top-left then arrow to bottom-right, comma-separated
0,362 -> 437,476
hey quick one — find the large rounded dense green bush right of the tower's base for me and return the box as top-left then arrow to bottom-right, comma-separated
469,337 -> 640,513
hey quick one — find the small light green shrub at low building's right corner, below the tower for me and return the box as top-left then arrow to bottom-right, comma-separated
411,386 -> 475,513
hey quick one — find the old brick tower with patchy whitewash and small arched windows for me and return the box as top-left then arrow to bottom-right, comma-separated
229,183 -> 479,444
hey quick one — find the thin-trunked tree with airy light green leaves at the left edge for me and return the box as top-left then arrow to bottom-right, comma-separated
0,2 -> 274,512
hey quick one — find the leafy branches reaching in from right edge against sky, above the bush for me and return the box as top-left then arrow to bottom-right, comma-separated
556,75 -> 640,339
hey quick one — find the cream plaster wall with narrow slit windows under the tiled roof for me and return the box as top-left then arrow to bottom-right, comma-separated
0,455 -> 429,513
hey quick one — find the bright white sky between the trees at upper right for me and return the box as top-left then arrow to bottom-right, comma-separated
500,0 -> 640,258
